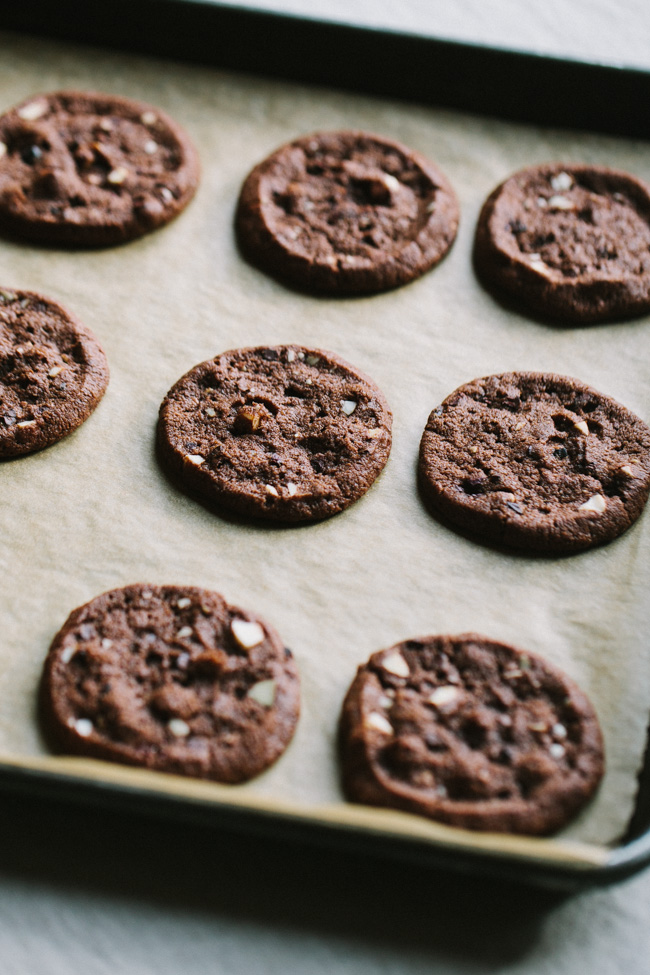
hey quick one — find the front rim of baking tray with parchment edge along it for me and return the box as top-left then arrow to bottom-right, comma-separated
0,757 -> 636,890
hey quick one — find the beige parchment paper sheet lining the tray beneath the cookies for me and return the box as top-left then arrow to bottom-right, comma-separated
0,34 -> 650,859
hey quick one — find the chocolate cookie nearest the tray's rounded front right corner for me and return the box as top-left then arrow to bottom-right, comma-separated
340,633 -> 604,834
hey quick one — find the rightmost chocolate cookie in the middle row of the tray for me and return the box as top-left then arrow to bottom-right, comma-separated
419,372 -> 650,555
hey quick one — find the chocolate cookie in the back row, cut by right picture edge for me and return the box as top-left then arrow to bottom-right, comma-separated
474,164 -> 650,323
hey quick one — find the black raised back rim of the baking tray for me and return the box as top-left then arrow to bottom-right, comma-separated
0,0 -> 650,139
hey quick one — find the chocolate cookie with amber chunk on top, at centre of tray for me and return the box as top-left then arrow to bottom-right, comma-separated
158,345 -> 392,522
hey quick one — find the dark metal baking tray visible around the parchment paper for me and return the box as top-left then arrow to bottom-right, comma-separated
0,0 -> 650,888
